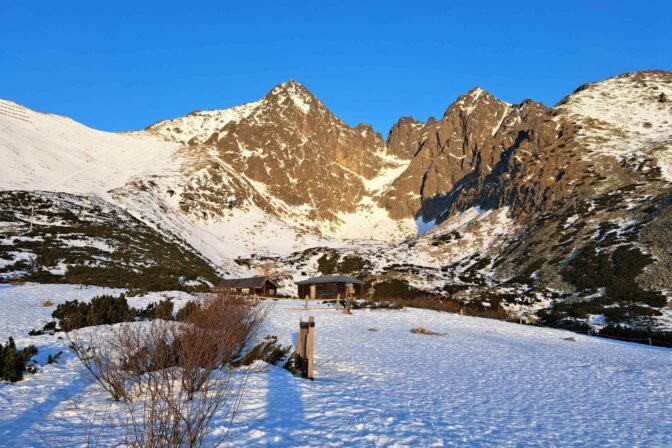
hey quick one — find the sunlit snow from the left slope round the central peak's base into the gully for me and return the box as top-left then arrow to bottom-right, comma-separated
0,96 -> 415,274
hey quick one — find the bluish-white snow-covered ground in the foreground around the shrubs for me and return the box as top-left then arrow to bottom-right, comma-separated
0,285 -> 672,447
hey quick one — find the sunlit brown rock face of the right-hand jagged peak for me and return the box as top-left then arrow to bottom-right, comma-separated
382,88 -> 555,222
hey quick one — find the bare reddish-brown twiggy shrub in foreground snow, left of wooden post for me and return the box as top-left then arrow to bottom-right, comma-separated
68,295 -> 269,448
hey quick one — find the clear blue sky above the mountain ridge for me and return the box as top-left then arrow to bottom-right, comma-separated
0,0 -> 672,135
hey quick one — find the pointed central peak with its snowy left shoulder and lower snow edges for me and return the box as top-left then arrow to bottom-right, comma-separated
145,81 -> 412,238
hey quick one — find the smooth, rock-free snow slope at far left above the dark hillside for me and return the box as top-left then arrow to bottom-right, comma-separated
0,100 -> 179,195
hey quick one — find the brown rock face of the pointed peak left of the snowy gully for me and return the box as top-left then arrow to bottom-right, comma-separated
211,82 -> 385,218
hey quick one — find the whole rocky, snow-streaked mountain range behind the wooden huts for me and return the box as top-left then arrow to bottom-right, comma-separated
0,71 -> 672,336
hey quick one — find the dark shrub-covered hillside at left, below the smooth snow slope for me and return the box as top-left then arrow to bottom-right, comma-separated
0,191 -> 221,290
